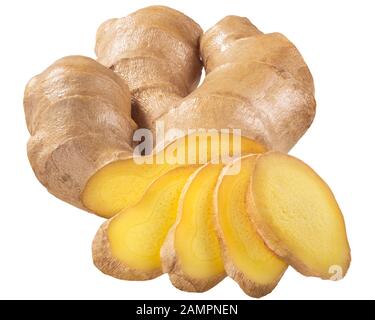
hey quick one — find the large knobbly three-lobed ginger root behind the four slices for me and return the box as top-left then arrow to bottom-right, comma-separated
25,6 -> 315,218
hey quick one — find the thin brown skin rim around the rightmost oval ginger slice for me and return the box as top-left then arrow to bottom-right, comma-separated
247,152 -> 351,280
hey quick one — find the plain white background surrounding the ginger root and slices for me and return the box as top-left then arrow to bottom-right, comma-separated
0,0 -> 375,299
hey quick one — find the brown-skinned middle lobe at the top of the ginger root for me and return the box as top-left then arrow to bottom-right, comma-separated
95,6 -> 202,129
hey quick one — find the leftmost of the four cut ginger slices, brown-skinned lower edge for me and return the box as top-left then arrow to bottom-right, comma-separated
93,166 -> 201,280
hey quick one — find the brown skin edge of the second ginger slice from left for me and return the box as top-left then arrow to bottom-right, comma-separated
160,165 -> 226,292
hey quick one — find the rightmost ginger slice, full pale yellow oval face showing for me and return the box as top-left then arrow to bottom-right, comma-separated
248,152 -> 350,280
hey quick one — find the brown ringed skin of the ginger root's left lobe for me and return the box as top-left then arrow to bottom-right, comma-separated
24,56 -> 136,210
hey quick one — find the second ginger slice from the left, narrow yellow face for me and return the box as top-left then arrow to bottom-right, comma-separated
160,163 -> 225,292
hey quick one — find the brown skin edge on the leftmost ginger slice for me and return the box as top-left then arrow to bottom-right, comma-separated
92,219 -> 162,280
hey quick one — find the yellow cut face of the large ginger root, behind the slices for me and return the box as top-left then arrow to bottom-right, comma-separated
81,133 -> 265,218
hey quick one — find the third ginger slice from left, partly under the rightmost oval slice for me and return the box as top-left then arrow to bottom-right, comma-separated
214,155 -> 287,297
